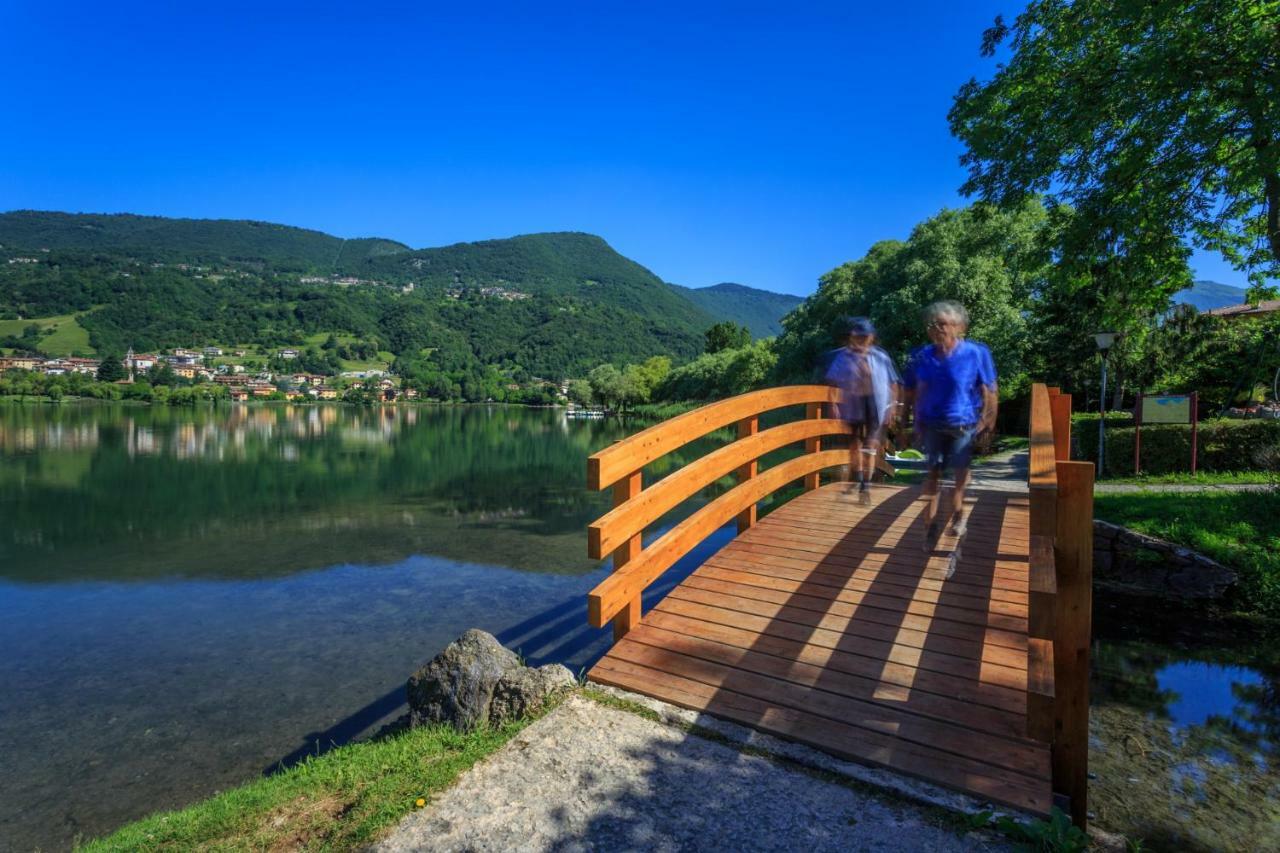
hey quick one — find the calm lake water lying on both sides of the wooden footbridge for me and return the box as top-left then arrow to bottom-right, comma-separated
0,405 -> 1280,850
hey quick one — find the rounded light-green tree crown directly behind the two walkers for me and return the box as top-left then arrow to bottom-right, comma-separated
777,201 -> 1053,396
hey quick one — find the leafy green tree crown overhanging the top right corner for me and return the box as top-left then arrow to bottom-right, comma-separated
948,0 -> 1280,292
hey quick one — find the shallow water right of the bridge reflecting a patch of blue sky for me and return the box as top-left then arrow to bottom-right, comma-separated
1089,596 -> 1280,850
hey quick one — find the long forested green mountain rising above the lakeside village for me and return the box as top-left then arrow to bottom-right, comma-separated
0,211 -> 721,386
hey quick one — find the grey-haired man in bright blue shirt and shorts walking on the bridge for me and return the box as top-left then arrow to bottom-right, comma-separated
902,301 -> 996,537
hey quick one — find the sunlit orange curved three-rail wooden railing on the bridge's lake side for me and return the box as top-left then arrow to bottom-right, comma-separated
586,386 -> 850,638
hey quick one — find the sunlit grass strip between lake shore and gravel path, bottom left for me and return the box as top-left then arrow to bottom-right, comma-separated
79,701 -> 555,852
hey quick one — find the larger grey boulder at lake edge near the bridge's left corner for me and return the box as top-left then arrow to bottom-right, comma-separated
408,629 -> 524,731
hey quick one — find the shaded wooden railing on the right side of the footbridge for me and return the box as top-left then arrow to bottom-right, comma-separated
1027,384 -> 1093,827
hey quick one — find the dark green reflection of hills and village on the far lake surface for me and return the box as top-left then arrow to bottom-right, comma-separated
0,406 -> 640,581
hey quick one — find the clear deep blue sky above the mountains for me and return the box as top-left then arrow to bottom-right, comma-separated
0,0 -> 1244,293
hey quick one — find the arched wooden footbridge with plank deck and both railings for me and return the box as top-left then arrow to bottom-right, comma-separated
588,386 -> 1093,826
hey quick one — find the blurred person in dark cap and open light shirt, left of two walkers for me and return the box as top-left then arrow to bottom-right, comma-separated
826,316 -> 901,503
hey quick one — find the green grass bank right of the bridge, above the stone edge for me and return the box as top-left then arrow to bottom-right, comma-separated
1094,489 -> 1280,616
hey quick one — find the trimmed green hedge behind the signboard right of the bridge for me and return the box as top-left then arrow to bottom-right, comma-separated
1071,412 -> 1280,476
